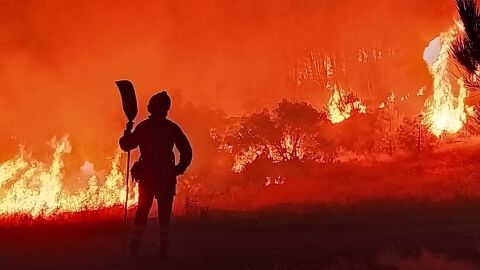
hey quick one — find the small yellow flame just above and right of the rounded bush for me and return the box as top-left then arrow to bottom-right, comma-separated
327,84 -> 367,124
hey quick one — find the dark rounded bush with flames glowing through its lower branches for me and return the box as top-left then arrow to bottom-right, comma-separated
213,100 -> 331,172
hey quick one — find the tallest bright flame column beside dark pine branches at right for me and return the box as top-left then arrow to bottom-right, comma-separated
422,26 -> 467,137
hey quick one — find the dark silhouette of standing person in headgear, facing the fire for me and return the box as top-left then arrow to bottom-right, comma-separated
120,91 -> 192,257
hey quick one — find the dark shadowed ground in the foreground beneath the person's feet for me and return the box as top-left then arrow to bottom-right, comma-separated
0,200 -> 480,270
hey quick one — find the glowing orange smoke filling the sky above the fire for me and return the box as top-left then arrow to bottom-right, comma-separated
0,0 -> 455,168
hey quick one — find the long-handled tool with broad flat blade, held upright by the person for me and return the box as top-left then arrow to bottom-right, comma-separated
115,80 -> 138,248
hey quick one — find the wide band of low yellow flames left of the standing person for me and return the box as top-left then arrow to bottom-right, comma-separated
0,138 -> 138,218
